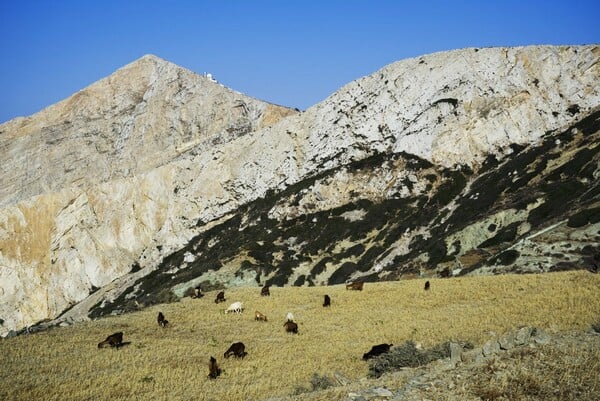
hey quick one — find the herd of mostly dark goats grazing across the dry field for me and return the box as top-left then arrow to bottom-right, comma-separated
98,281 -> 430,379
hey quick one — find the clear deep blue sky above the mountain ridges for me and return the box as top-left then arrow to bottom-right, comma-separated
0,0 -> 600,123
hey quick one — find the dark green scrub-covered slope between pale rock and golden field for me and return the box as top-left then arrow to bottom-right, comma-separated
91,111 -> 600,316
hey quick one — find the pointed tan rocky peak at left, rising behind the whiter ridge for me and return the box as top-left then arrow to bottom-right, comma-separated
0,56 -> 294,205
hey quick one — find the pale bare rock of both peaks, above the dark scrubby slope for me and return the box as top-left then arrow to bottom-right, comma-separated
0,46 -> 600,335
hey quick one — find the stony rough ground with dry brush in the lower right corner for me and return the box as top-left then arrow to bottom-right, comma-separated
276,327 -> 600,401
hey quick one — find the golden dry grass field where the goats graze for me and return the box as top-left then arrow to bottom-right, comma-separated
0,271 -> 600,401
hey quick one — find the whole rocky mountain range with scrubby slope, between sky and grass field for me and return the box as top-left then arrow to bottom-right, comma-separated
0,45 -> 600,333
